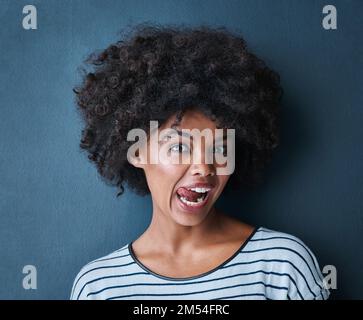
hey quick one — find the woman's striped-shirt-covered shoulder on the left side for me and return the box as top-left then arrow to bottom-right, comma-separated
70,244 -> 134,300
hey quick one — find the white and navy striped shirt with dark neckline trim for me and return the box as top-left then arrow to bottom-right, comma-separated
71,227 -> 329,300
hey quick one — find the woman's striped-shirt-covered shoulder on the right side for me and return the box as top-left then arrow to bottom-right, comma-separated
244,227 -> 329,299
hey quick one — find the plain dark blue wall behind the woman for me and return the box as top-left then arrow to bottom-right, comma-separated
0,0 -> 363,299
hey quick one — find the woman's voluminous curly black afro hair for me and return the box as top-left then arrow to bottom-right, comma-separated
73,24 -> 283,196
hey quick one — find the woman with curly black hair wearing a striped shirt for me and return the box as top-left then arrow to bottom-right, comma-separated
71,26 -> 329,300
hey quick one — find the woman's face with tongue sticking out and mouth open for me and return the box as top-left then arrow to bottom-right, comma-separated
132,109 -> 230,226
